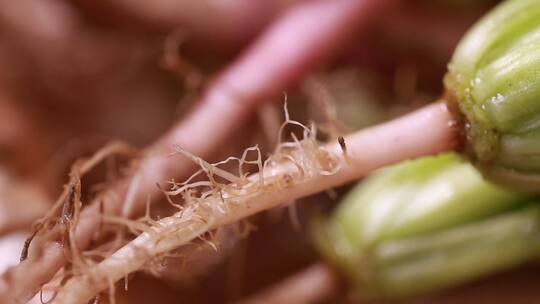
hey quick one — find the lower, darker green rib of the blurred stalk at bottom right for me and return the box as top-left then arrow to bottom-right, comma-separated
371,205 -> 540,297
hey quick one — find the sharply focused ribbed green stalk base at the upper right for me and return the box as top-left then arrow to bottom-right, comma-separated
445,0 -> 540,190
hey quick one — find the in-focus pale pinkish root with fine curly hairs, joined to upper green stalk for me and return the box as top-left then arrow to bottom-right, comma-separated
49,104 -> 455,303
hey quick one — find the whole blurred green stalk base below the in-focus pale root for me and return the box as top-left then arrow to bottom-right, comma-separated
314,154 -> 540,297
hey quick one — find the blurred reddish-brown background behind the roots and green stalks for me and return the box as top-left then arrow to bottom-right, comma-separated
5,0 -> 539,303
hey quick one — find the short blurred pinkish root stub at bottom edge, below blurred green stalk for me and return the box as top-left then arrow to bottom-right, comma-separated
237,263 -> 339,304
